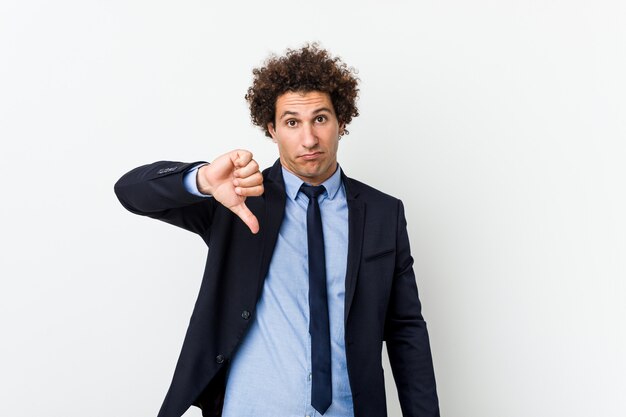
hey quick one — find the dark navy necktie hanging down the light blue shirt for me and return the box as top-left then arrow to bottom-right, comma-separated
300,184 -> 332,414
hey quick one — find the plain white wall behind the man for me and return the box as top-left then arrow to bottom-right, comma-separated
0,0 -> 626,417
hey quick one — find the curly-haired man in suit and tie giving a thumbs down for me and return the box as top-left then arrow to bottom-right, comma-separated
115,44 -> 439,417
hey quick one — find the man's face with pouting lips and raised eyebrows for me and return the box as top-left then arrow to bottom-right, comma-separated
268,91 -> 343,185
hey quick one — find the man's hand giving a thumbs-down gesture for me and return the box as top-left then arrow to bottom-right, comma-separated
196,149 -> 263,233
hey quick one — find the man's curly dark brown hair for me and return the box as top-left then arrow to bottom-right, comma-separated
246,43 -> 359,137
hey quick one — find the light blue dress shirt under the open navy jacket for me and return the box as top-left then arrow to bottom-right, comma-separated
185,166 -> 354,417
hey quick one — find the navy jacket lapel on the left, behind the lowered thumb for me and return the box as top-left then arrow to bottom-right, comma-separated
257,160 -> 286,298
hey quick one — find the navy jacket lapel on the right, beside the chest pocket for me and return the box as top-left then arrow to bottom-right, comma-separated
341,172 -> 365,325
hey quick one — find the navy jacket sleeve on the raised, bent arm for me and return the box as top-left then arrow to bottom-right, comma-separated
114,161 -> 217,237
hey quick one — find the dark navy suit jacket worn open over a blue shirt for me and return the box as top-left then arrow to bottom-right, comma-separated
115,161 -> 439,417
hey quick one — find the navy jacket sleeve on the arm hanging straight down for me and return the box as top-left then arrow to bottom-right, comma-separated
385,202 -> 439,417
